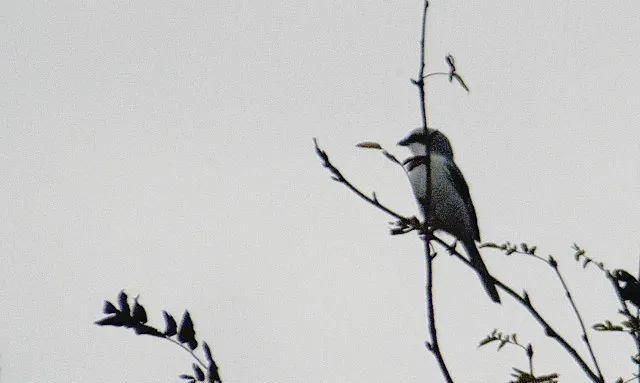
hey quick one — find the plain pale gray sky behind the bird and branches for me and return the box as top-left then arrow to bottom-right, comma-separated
0,0 -> 640,383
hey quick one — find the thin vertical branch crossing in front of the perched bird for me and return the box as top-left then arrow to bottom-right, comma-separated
412,0 -> 453,383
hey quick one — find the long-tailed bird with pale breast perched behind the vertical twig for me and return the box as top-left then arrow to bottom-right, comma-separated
398,128 -> 501,303
